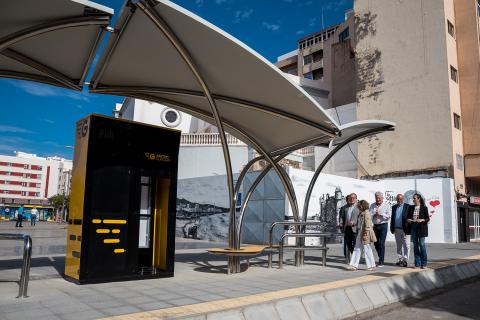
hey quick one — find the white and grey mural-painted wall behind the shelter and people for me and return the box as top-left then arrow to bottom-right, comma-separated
176,169 -> 458,243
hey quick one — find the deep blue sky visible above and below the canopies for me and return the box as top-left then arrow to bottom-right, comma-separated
0,0 -> 353,159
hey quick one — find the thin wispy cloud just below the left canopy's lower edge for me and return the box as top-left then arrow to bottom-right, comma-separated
8,80 -> 90,102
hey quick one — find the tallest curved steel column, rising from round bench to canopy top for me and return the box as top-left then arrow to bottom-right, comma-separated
133,0 -> 240,272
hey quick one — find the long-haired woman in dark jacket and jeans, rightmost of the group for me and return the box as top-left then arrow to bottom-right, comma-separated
407,193 -> 430,269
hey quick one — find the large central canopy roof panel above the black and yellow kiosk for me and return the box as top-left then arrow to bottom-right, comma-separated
90,0 -> 393,153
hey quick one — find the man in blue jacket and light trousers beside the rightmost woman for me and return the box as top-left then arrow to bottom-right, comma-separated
390,193 -> 410,267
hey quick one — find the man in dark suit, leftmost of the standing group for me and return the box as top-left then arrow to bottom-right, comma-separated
338,193 -> 359,263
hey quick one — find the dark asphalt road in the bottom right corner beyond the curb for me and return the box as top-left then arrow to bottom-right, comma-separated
369,278 -> 480,320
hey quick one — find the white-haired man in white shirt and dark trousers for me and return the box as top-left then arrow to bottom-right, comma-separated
370,191 -> 392,267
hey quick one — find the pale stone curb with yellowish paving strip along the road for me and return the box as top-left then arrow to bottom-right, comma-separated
103,256 -> 480,320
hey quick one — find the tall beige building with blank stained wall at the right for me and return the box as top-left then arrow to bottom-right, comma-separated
354,0 -> 480,201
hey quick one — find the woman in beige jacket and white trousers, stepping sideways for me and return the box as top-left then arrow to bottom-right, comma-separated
347,200 -> 377,271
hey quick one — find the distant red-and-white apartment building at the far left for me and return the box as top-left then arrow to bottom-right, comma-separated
0,152 -> 72,205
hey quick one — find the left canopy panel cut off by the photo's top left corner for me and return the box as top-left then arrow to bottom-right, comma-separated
0,0 -> 113,90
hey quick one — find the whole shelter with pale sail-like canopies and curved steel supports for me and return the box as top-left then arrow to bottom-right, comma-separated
0,0 -> 395,272
